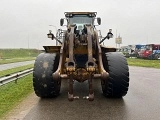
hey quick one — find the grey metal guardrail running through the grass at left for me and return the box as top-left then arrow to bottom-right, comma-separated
0,68 -> 33,86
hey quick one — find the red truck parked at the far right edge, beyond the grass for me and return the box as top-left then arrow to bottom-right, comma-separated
139,44 -> 160,59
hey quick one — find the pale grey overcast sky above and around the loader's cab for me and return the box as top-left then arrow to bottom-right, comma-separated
0,0 -> 160,49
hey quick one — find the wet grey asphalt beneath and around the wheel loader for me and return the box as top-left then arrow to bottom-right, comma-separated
5,67 -> 160,120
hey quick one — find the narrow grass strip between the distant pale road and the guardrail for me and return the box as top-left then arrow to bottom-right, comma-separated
0,64 -> 33,77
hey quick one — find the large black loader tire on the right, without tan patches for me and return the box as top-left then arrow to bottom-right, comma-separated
101,52 -> 129,98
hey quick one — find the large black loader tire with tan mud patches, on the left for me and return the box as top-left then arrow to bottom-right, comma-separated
33,53 -> 61,98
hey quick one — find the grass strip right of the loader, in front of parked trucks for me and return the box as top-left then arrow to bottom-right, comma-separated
127,58 -> 160,69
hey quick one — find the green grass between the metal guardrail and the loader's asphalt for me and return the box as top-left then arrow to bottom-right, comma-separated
0,74 -> 33,119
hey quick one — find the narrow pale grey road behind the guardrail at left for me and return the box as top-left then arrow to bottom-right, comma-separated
0,60 -> 34,71
